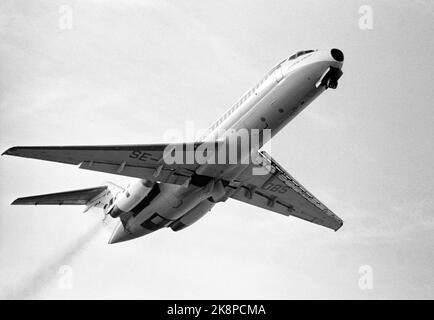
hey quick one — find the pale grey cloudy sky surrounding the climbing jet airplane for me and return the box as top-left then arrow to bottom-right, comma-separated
0,0 -> 434,299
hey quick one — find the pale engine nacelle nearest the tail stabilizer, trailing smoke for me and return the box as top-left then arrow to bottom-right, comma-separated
109,180 -> 154,218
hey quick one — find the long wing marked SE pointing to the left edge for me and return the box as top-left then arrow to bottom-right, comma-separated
3,143 -> 205,185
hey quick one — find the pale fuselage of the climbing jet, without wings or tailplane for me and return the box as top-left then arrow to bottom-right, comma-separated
110,51 -> 342,243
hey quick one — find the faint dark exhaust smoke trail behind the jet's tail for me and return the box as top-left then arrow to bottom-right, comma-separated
5,222 -> 105,299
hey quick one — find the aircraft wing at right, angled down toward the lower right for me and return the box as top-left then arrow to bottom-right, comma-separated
227,152 -> 343,231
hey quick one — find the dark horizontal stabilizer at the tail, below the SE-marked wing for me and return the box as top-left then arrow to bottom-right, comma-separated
12,186 -> 108,205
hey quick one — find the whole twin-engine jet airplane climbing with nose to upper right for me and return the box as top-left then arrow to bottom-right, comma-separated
3,48 -> 344,243
